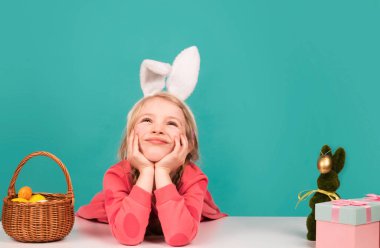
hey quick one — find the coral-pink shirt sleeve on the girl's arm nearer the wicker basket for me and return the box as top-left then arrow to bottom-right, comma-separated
103,168 -> 152,245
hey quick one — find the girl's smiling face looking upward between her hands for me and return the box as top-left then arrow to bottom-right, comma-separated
134,97 -> 186,162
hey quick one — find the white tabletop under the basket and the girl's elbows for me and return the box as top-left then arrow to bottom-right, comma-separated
0,217 -> 315,248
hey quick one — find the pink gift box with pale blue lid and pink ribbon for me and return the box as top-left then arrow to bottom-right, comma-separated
315,198 -> 380,248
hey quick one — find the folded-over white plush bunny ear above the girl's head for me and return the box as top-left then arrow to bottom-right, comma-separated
140,59 -> 171,96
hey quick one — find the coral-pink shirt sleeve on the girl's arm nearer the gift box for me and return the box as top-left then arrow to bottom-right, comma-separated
154,178 -> 207,246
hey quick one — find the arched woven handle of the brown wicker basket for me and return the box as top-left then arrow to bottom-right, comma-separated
8,151 -> 74,205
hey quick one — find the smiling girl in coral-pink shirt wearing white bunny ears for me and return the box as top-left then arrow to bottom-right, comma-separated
77,47 -> 226,246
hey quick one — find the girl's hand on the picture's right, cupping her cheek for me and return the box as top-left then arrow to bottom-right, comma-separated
155,134 -> 189,174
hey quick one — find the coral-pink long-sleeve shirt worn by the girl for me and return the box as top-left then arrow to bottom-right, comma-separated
77,160 -> 227,246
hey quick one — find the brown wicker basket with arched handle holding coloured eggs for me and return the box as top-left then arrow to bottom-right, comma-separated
2,151 -> 74,243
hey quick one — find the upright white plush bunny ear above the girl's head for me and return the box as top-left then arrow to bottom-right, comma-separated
166,46 -> 200,101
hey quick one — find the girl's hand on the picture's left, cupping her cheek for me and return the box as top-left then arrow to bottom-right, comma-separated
127,130 -> 154,173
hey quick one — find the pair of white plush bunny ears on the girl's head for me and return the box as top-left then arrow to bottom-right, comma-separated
140,46 -> 200,101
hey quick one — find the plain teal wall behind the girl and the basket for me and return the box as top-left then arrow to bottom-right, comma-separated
0,0 -> 380,216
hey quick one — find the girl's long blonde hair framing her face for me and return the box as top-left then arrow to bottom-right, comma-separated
118,92 -> 199,186
